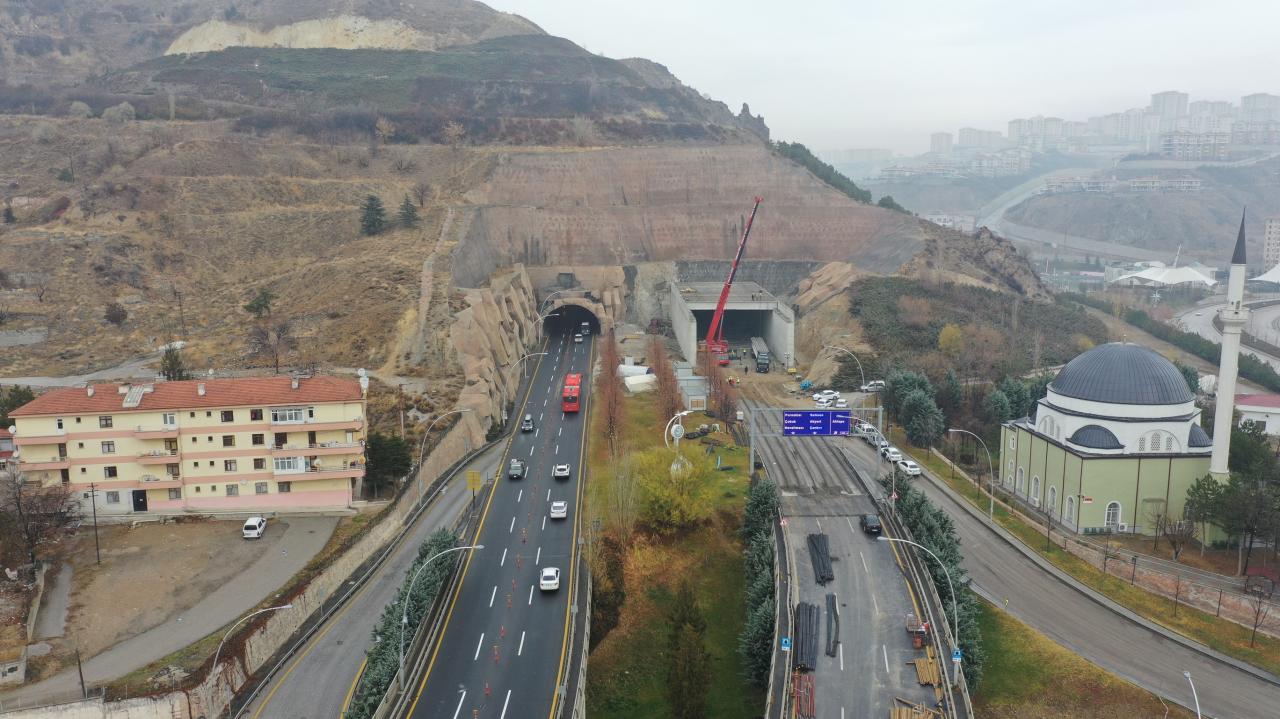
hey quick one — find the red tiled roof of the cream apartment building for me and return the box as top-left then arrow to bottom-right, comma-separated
9,375 -> 360,417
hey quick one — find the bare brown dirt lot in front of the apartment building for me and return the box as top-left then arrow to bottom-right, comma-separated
32,522 -> 284,676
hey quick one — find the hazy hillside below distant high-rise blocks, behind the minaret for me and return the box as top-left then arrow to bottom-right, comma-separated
1005,160 -> 1280,265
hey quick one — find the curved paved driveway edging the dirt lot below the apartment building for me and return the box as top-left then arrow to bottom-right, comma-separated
0,517 -> 338,706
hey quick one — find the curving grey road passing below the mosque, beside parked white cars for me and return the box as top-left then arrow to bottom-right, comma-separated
844,439 -> 1280,719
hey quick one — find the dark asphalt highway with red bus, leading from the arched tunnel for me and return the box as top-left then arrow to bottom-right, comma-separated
410,334 -> 594,719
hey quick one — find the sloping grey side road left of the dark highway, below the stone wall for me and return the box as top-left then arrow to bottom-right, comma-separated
241,443 -> 506,719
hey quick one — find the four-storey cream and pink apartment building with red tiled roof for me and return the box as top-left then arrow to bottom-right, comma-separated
9,376 -> 367,514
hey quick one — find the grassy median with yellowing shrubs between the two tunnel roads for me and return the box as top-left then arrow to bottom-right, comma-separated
586,395 -> 764,719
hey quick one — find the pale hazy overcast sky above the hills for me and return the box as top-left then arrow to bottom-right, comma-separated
488,0 -> 1280,154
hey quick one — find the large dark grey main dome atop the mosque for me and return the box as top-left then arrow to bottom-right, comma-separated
1048,342 -> 1194,404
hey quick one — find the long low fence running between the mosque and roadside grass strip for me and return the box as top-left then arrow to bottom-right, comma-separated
929,449 -> 1280,636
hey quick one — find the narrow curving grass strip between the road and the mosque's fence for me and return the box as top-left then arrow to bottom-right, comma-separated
890,430 -> 1280,674
